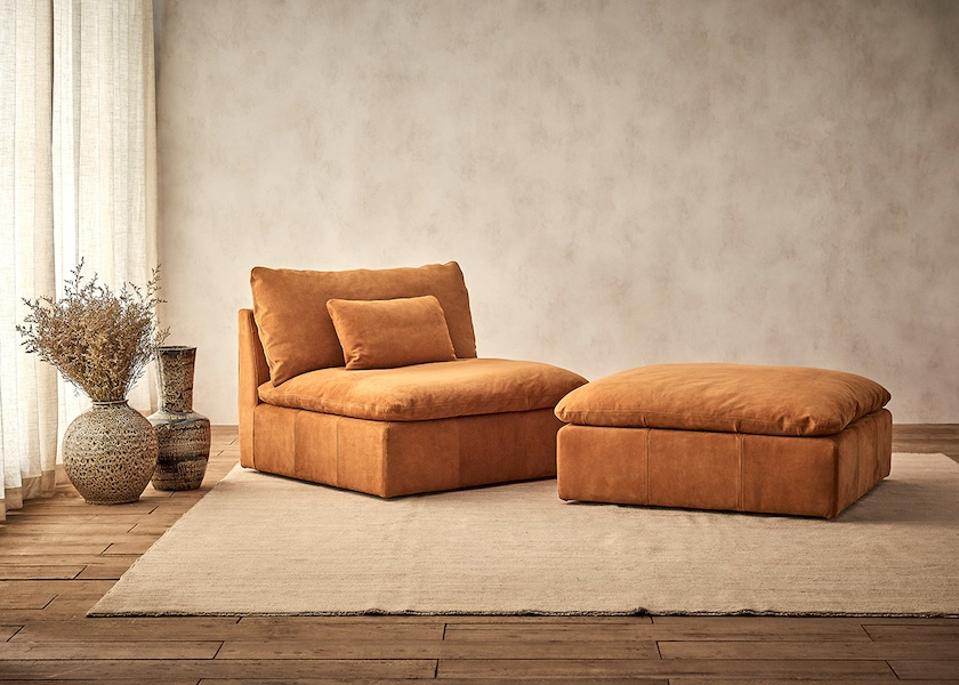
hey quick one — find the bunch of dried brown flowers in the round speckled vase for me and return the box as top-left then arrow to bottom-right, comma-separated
17,260 -> 169,402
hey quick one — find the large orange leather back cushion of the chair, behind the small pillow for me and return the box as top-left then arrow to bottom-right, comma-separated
250,262 -> 476,385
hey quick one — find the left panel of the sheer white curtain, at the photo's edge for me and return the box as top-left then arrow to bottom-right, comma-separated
0,0 -> 57,520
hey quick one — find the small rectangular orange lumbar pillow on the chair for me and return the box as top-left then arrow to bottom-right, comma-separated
326,295 -> 456,369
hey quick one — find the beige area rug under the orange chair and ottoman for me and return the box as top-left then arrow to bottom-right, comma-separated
91,454 -> 959,616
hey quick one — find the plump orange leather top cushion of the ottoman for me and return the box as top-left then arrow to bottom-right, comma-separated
556,364 -> 890,436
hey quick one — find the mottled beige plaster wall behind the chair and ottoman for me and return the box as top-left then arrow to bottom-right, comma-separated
158,0 -> 959,423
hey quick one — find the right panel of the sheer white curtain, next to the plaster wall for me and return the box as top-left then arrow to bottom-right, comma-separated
53,0 -> 157,444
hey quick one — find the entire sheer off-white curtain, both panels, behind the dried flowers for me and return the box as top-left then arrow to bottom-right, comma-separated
0,0 -> 156,519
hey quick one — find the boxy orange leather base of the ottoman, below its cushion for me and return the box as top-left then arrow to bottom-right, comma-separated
556,409 -> 892,518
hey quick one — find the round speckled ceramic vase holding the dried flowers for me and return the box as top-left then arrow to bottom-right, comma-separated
63,400 -> 157,504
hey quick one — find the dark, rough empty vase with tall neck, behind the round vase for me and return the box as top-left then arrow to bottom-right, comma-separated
150,347 -> 210,490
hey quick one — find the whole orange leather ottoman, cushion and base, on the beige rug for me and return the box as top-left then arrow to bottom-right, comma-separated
556,364 -> 892,518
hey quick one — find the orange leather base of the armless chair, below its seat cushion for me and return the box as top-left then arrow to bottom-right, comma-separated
240,404 -> 563,497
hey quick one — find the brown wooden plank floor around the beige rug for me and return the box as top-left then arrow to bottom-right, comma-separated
0,425 -> 959,685
